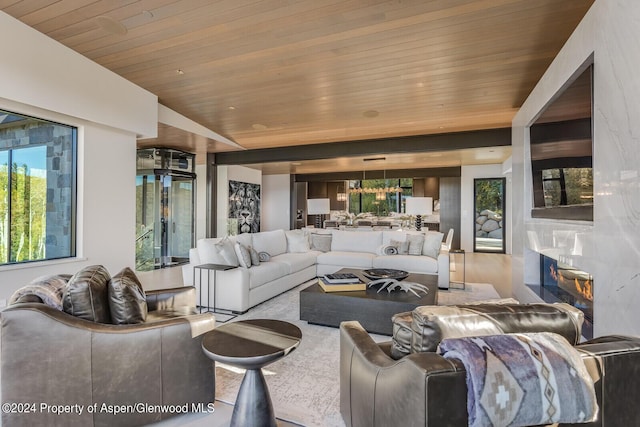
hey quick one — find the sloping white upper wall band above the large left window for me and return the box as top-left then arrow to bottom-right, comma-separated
0,12 -> 158,137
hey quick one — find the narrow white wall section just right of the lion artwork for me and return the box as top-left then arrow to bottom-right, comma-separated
262,174 -> 291,231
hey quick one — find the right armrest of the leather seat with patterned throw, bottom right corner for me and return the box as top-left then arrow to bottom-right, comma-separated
561,335 -> 640,427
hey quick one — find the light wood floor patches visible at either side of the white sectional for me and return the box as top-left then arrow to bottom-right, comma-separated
136,252 -> 512,298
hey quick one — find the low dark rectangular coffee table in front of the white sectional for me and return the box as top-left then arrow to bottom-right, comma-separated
300,268 -> 438,335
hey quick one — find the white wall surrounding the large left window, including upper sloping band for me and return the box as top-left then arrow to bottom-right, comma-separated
0,12 -> 157,303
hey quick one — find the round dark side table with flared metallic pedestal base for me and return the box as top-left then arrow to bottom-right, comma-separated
202,319 -> 302,427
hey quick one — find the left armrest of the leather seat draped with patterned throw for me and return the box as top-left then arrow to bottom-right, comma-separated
340,322 -> 468,427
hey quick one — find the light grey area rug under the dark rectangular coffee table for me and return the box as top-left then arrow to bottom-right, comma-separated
210,281 -> 499,427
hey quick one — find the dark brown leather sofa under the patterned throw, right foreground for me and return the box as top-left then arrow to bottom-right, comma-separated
340,304 -> 640,427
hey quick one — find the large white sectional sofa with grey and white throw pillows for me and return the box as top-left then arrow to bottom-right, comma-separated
182,230 -> 449,313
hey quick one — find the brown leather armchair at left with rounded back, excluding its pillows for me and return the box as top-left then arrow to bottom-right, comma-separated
0,287 -> 215,426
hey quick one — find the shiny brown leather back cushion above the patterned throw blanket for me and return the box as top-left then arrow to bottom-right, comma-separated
411,303 -> 584,353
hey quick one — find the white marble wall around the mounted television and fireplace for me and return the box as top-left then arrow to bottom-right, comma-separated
512,0 -> 640,336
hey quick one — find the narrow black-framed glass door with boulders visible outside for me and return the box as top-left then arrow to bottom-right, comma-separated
473,178 -> 506,254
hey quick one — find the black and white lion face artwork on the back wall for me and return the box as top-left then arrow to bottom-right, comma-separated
229,181 -> 260,233
